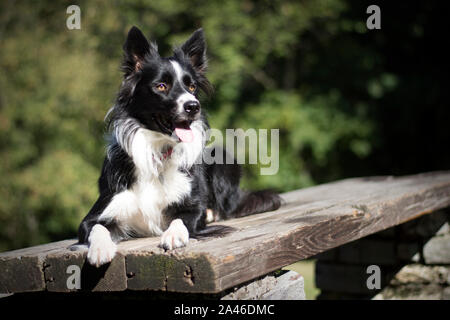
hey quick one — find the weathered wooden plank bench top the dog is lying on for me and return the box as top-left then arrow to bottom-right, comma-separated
0,172 -> 450,293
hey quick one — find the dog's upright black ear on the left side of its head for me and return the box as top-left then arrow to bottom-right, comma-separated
123,26 -> 158,75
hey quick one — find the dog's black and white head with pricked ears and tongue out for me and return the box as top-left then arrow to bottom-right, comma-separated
118,27 -> 211,142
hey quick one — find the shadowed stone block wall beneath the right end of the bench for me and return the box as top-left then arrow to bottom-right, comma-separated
315,209 -> 450,299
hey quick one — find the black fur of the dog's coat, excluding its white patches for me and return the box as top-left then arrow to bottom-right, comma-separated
78,27 -> 280,250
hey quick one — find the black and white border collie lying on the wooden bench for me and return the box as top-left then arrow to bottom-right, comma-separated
78,27 -> 280,266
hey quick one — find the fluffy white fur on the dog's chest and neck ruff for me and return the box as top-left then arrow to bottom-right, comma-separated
99,120 -> 206,243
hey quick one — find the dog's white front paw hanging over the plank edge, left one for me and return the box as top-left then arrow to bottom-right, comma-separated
87,224 -> 117,268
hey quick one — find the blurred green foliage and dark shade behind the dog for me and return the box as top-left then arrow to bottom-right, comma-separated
0,0 -> 450,251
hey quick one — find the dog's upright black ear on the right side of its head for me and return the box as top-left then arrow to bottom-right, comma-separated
181,28 -> 207,73
